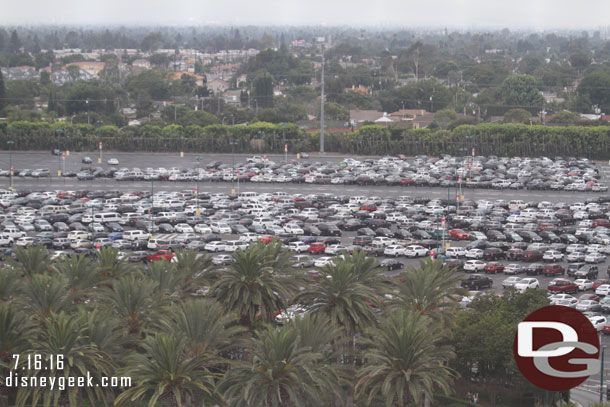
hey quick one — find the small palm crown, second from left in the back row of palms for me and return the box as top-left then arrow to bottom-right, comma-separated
52,254 -> 100,295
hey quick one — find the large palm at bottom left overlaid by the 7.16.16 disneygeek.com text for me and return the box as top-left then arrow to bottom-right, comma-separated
16,312 -> 114,407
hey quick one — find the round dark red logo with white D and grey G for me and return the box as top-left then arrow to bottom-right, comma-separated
513,305 -> 600,391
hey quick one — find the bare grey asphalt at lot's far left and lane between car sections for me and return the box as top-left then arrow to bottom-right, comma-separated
0,151 -> 610,203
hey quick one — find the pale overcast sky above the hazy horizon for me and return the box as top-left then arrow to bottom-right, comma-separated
0,0 -> 610,29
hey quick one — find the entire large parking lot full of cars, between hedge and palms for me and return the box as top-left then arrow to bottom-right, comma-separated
0,153 -> 610,344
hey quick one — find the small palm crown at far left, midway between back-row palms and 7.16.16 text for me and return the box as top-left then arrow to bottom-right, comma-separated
17,274 -> 72,321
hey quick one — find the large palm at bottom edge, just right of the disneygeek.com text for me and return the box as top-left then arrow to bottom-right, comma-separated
115,333 -> 216,407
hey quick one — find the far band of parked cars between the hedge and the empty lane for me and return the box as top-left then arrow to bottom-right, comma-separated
13,154 -> 607,192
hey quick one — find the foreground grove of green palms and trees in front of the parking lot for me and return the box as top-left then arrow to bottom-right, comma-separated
0,242 -> 555,407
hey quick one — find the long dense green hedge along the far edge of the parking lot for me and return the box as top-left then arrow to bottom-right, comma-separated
0,122 -> 610,159
